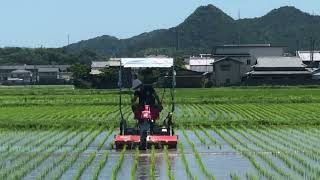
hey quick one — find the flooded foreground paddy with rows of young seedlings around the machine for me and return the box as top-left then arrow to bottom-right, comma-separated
0,128 -> 319,180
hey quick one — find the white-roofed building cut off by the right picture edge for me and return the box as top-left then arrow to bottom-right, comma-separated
296,51 -> 320,68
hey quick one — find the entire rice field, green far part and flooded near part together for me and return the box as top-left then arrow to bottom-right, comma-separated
0,86 -> 320,180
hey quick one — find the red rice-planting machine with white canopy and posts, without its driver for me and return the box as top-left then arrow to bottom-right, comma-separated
114,58 -> 178,149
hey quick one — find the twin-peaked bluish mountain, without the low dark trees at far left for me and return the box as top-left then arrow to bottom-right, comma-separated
66,5 -> 320,56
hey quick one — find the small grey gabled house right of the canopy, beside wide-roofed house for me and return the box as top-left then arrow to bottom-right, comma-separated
212,57 -> 243,86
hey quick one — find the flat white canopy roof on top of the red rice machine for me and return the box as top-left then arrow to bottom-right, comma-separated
121,57 -> 173,68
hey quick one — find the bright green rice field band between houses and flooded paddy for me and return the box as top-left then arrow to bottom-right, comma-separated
0,86 -> 320,129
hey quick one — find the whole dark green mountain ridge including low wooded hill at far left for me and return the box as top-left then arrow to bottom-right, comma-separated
0,5 -> 320,65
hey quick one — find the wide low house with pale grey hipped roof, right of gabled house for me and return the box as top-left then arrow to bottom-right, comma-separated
246,56 -> 312,84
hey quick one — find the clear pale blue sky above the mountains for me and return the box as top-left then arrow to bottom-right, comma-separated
0,0 -> 320,48
